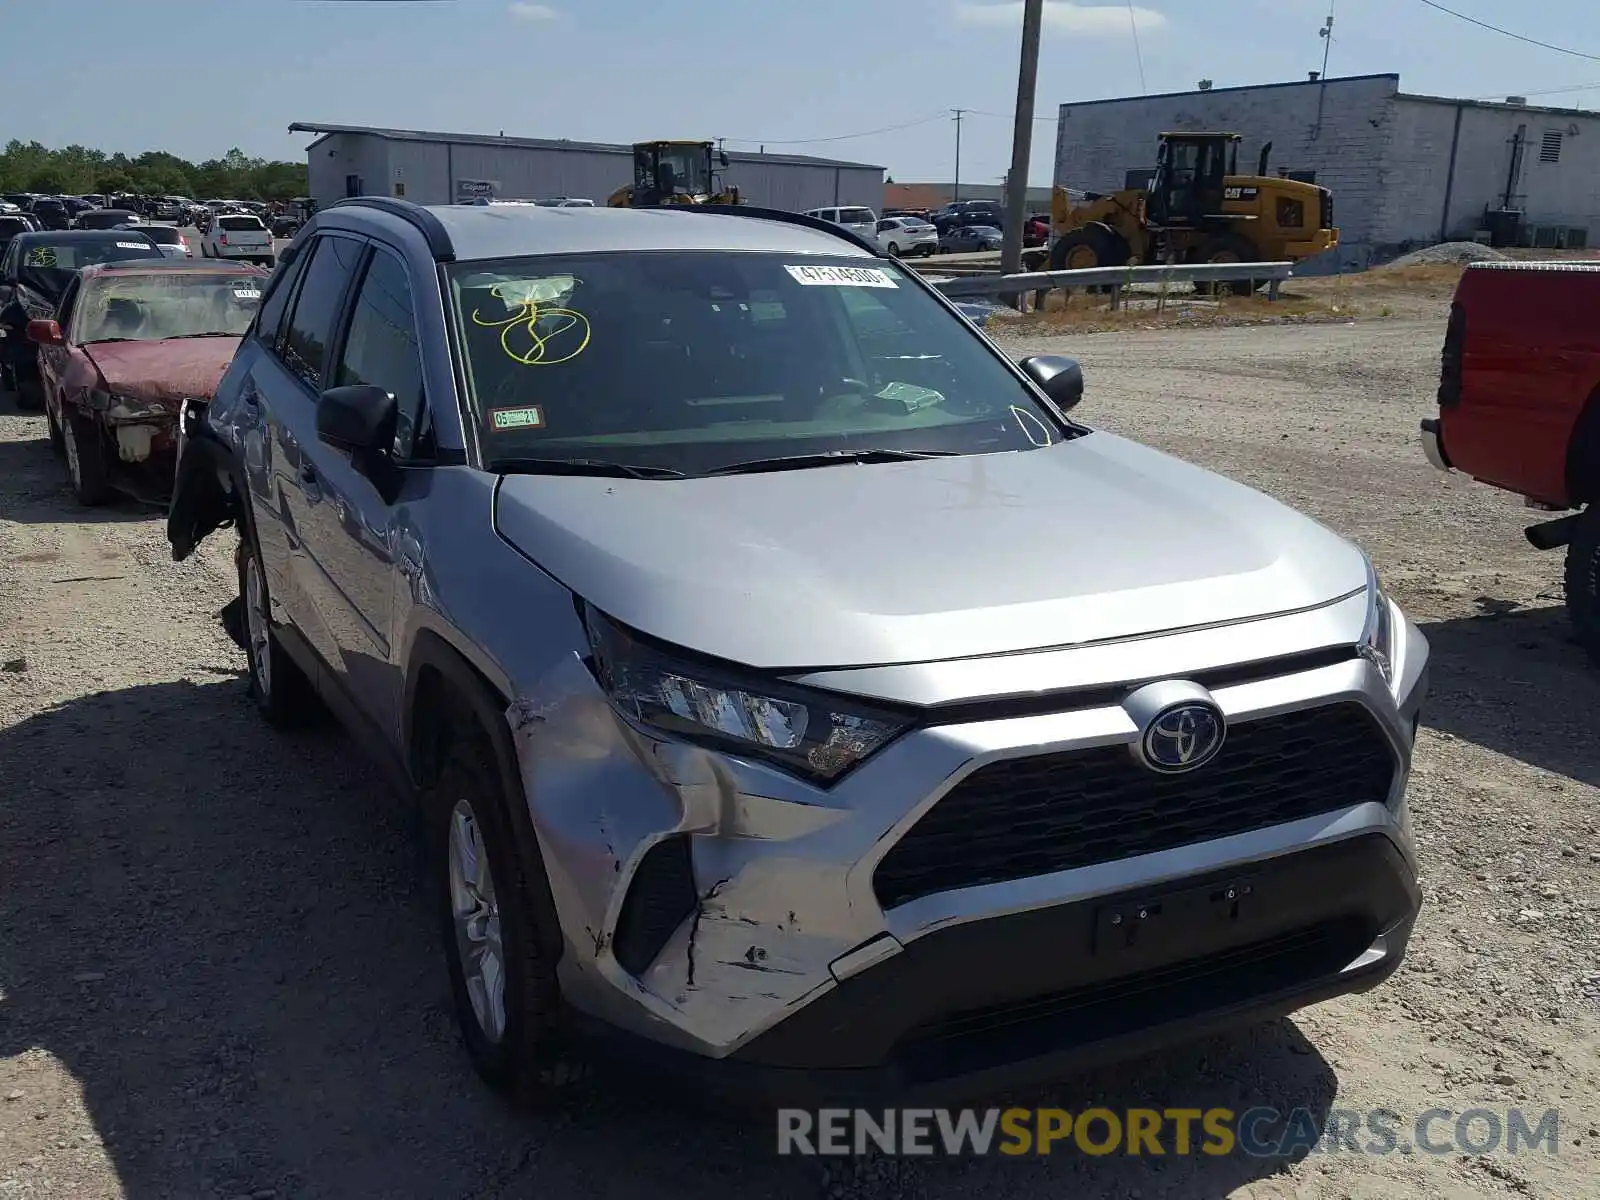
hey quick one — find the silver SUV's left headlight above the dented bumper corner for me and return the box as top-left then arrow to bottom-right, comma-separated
586,608 -> 907,784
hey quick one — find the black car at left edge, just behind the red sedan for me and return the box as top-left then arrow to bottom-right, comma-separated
0,229 -> 163,408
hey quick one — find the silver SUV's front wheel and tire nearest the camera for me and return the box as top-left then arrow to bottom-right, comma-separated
422,729 -> 568,1104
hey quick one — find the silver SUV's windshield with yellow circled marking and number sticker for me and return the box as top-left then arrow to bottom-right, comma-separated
450,251 -> 1067,474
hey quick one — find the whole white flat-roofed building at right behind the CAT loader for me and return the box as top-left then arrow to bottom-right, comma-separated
1056,75 -> 1600,270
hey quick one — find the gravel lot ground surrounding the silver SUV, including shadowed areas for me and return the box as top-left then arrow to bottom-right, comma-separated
0,322 -> 1600,1200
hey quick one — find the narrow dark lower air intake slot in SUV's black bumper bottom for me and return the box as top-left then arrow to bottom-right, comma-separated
896,917 -> 1378,1075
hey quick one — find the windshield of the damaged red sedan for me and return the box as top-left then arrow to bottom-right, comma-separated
75,270 -> 266,346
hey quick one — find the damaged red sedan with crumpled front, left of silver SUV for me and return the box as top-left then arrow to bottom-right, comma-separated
27,259 -> 269,504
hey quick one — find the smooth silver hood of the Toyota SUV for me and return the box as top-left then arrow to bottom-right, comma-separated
496,432 -> 1366,669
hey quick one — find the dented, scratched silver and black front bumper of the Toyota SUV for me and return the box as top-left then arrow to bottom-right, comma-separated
507,598 -> 1427,1096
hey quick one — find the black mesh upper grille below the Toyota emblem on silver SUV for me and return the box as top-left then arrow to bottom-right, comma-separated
874,702 -> 1395,909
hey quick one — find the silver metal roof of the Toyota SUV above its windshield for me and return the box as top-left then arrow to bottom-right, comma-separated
315,203 -> 869,262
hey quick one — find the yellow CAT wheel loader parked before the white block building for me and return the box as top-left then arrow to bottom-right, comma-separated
1034,133 -> 1339,293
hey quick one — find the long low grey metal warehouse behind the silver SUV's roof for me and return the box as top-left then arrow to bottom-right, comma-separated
290,122 -> 883,211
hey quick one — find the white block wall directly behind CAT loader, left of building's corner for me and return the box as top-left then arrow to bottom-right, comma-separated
1054,75 -> 1400,274
